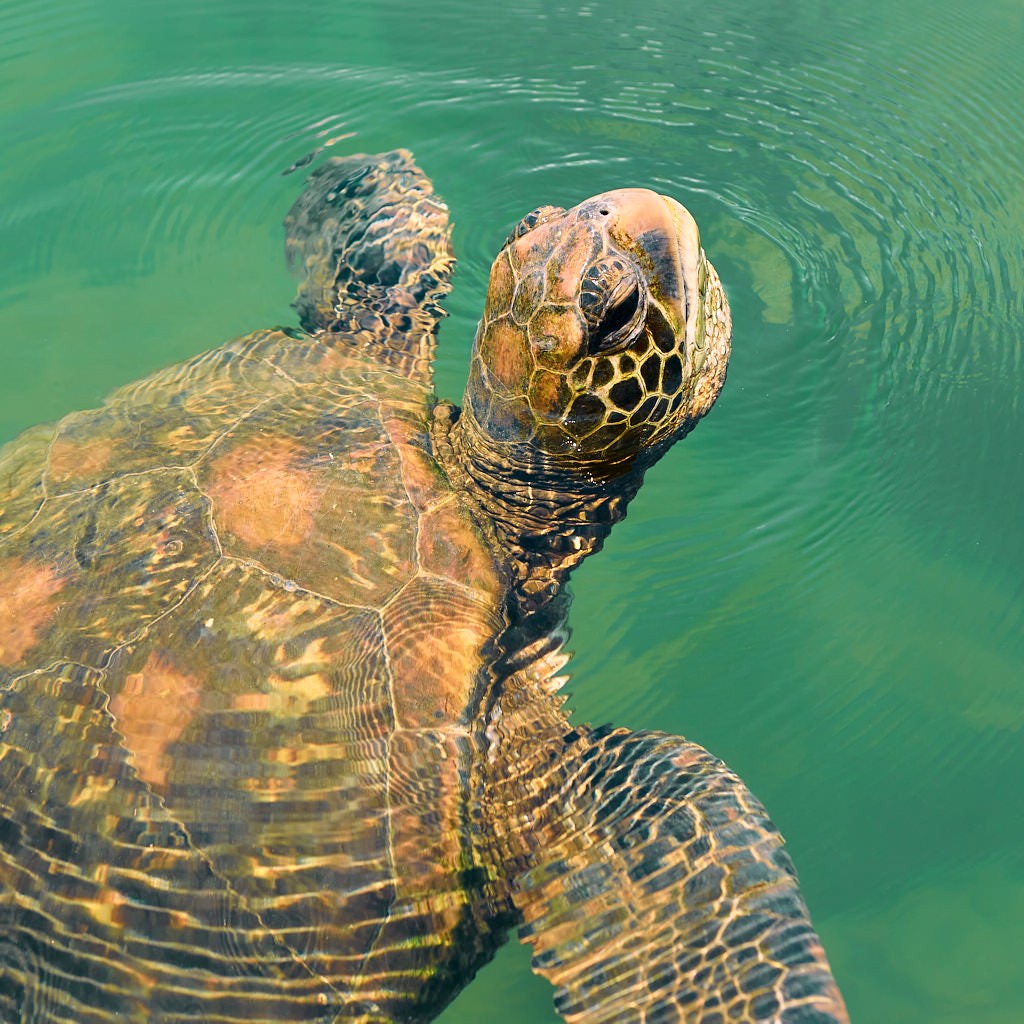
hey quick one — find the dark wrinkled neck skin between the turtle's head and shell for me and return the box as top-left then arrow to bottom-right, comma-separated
433,402 -> 647,617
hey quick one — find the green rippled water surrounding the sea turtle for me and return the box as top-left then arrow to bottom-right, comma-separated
0,0 -> 1024,1024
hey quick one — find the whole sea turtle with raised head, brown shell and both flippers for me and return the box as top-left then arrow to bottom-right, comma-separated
0,152 -> 847,1024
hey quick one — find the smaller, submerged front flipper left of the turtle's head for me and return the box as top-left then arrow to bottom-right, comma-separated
285,150 -> 455,381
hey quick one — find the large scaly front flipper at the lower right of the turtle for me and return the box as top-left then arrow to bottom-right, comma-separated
515,730 -> 849,1024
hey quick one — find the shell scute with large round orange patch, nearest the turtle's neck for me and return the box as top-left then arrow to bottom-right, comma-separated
191,386 -> 428,608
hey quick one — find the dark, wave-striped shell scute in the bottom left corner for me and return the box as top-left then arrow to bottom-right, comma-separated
0,663 -> 319,1021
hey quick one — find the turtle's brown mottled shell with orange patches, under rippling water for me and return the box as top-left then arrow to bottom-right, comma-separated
0,317 -> 502,1021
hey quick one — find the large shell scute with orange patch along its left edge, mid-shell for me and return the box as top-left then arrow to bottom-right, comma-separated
99,560 -> 392,913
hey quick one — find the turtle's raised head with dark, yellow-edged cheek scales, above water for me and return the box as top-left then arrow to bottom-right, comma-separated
465,188 -> 731,478
